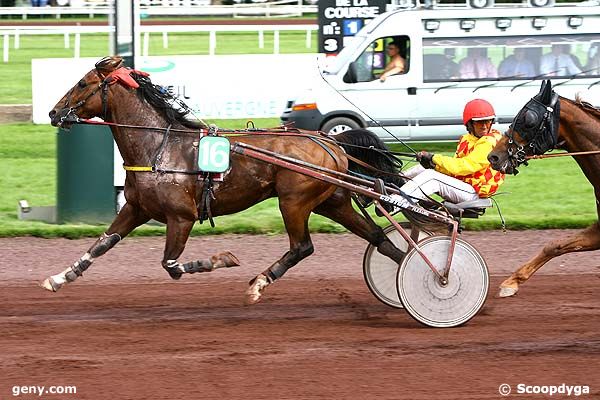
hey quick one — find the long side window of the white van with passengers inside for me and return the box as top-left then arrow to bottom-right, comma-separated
423,34 -> 600,82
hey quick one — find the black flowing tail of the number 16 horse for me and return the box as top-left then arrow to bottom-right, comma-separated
331,129 -> 405,187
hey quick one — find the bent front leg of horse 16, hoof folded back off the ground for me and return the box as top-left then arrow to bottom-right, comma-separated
162,219 -> 240,280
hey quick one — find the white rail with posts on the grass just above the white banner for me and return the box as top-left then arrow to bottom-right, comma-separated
0,25 -> 318,63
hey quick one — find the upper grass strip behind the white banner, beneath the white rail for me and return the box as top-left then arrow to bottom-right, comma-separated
0,31 -> 317,104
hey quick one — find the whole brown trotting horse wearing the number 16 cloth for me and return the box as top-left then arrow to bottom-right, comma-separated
42,57 -> 404,303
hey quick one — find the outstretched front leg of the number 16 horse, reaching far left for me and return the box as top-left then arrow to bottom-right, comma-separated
40,203 -> 149,292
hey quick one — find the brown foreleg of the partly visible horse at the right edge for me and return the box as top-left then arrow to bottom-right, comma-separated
498,222 -> 600,297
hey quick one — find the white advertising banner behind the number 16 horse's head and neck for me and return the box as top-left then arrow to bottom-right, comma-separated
32,54 -> 320,124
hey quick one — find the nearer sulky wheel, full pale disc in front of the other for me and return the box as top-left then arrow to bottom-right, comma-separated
397,236 -> 489,328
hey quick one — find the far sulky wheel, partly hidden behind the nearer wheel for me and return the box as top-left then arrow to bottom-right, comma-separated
363,223 -> 429,308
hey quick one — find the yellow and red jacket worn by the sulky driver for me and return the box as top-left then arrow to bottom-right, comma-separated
433,129 -> 505,197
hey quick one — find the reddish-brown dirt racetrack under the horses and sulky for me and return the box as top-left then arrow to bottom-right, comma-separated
0,231 -> 600,400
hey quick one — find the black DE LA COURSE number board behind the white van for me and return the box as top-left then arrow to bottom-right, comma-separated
319,0 -> 387,54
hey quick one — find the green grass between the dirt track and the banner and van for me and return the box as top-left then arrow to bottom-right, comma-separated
0,118 -> 597,238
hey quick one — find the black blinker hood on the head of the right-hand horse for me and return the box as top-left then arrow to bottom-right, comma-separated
505,92 -> 560,167
